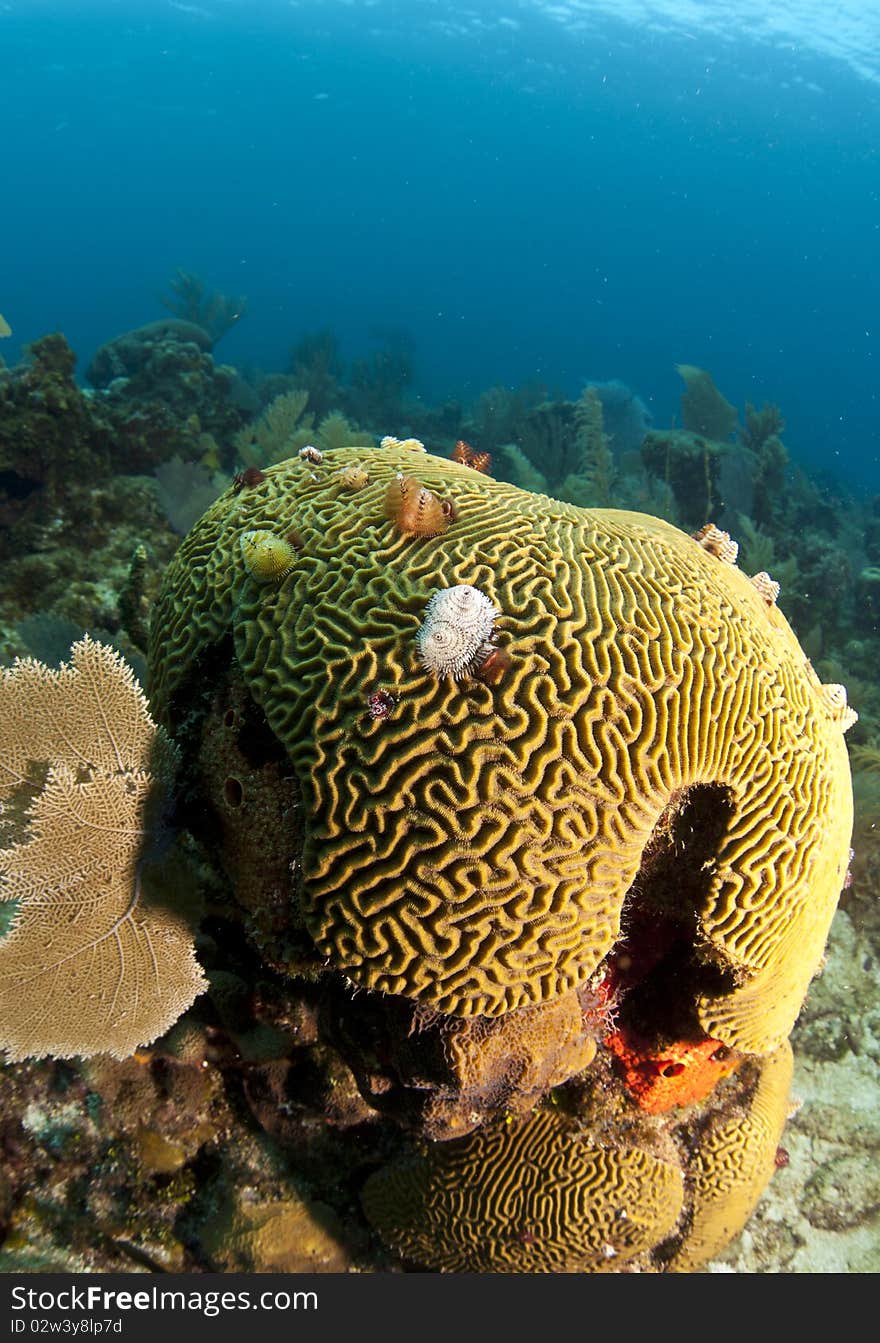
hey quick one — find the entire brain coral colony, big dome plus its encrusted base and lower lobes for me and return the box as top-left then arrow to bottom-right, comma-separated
149,439 -> 852,1272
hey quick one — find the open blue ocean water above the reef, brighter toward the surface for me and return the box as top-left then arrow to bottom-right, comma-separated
0,0 -> 880,489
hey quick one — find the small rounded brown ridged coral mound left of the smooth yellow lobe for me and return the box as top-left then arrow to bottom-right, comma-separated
363,1111 -> 683,1273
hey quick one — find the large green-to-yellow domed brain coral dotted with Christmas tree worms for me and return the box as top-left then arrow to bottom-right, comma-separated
150,446 -> 852,1053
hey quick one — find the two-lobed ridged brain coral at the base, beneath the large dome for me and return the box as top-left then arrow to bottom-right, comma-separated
361,1042 -> 791,1273
